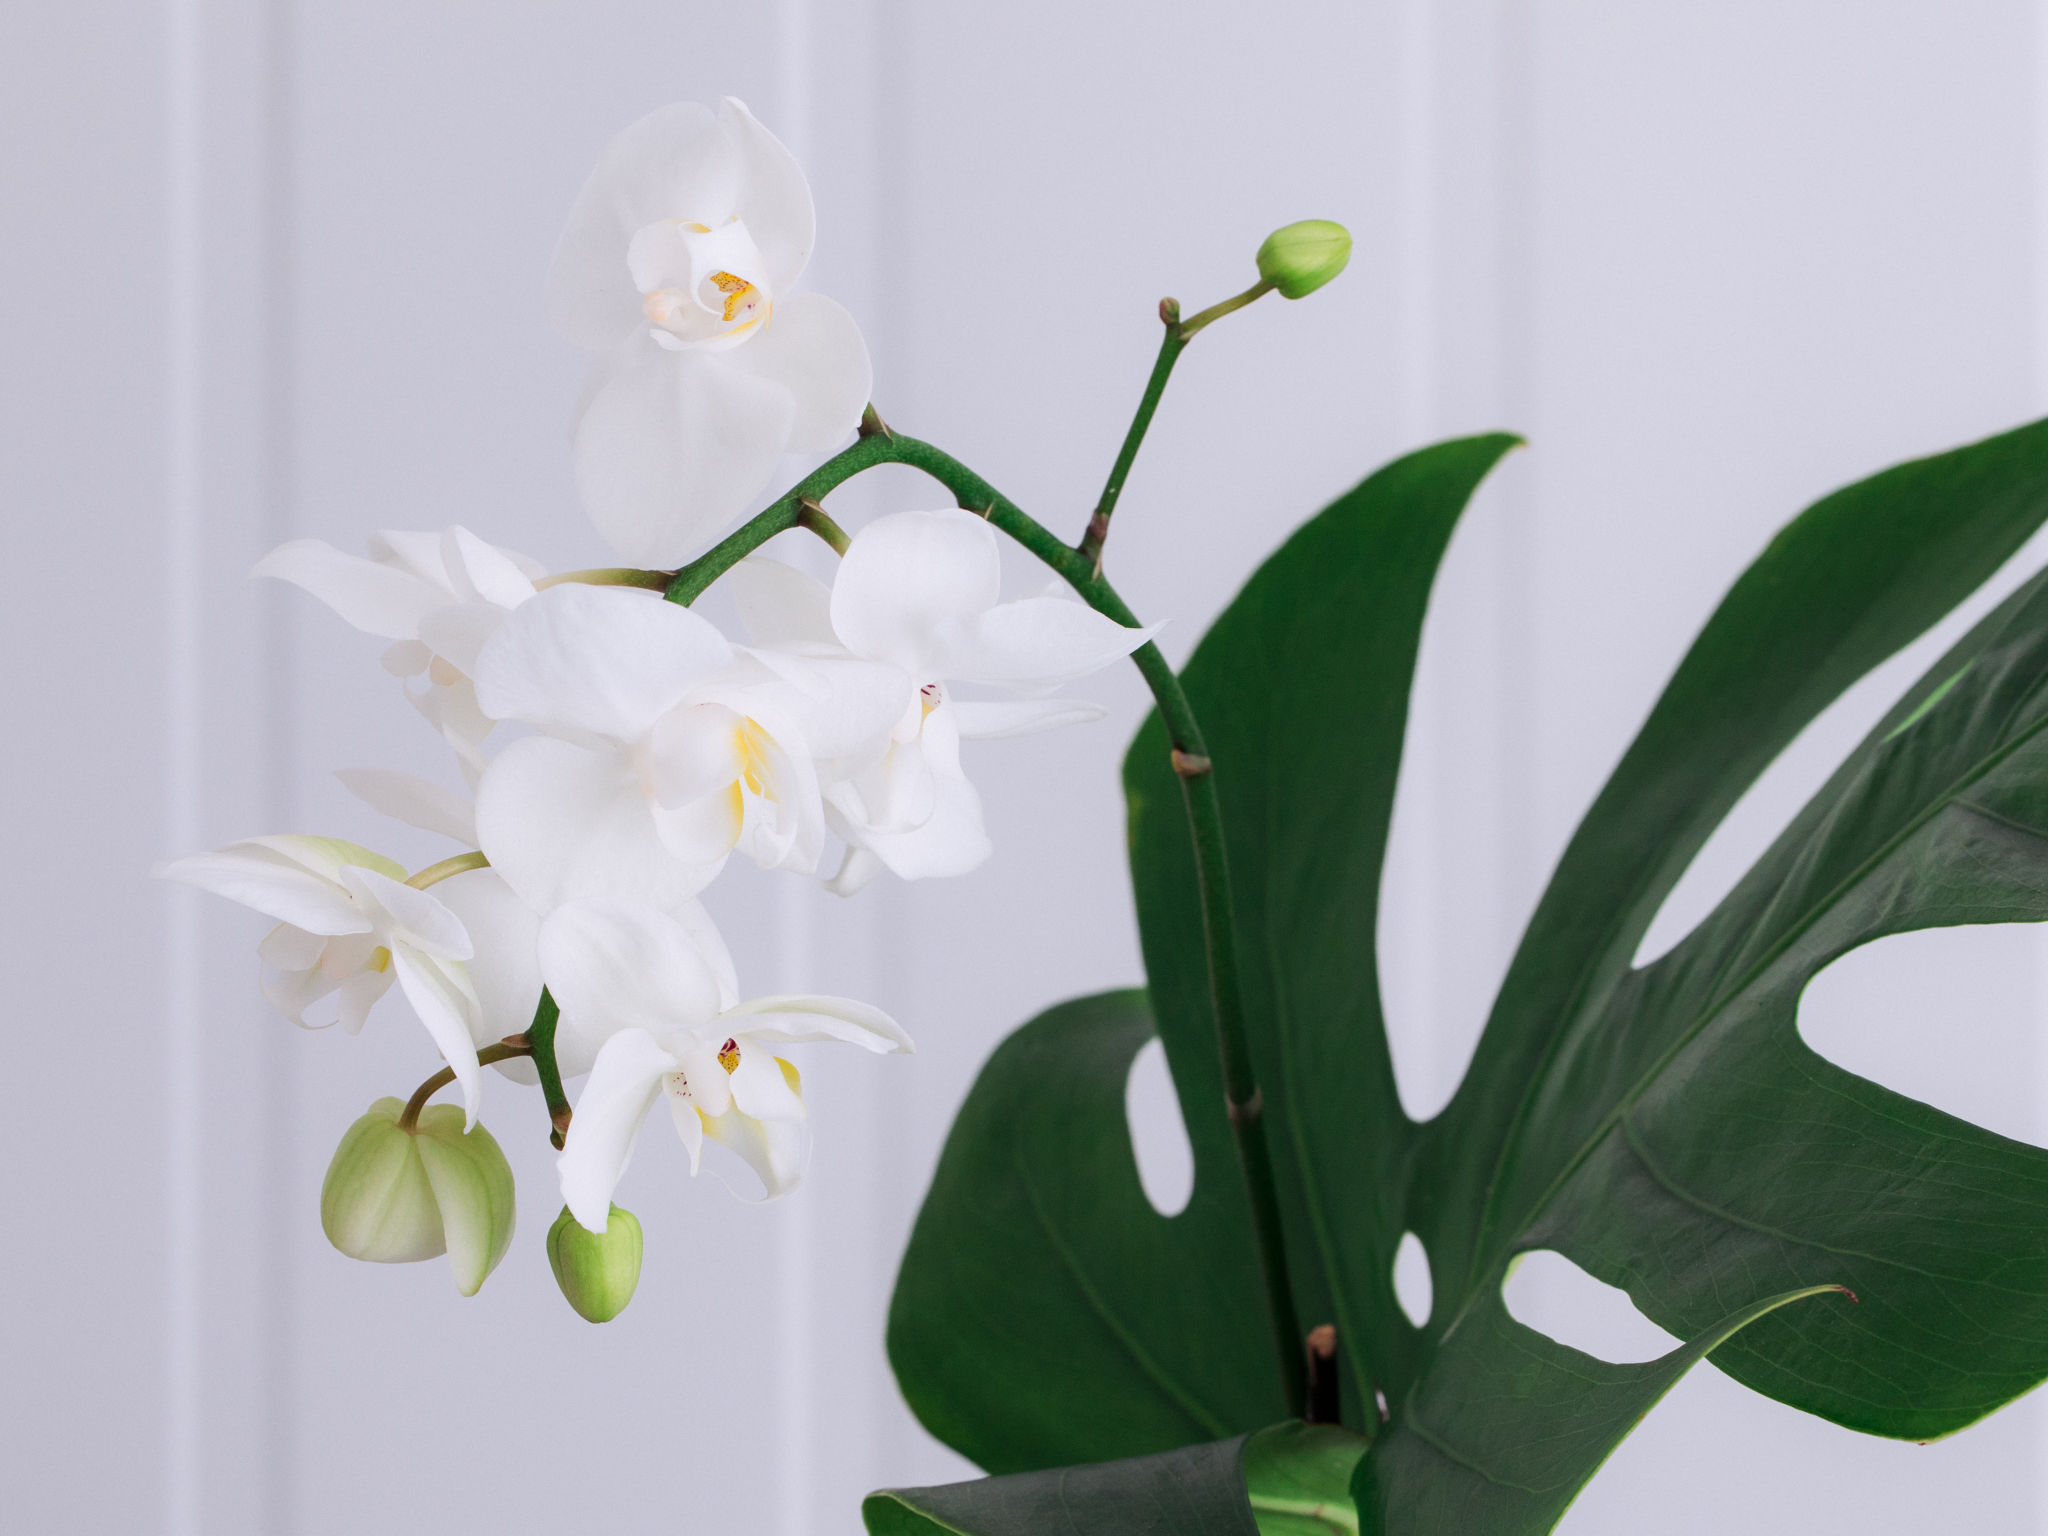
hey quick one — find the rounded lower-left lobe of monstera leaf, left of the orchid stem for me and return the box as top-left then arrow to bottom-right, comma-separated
889,991 -> 1288,1473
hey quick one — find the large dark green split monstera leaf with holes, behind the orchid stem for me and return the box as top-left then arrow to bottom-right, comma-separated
870,426 -> 2048,1536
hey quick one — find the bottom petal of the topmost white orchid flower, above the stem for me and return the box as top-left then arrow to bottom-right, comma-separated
575,338 -> 797,569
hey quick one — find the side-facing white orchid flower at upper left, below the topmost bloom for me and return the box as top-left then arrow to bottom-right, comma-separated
250,524 -> 545,782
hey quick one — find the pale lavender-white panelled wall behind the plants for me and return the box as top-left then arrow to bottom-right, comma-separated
12,0 -> 2048,1536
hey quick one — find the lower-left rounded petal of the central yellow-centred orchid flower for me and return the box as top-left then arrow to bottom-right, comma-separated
477,737 -> 721,911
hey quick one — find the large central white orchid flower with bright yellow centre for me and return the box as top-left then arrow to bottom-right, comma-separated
477,586 -> 897,911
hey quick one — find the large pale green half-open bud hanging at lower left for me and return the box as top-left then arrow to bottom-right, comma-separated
319,1098 -> 514,1296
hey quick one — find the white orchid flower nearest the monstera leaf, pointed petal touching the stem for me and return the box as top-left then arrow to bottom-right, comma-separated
731,508 -> 1155,893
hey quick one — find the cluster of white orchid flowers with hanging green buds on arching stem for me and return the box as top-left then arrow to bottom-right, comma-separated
160,100 -> 1335,1359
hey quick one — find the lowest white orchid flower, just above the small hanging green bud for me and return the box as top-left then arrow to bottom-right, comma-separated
541,899 -> 911,1233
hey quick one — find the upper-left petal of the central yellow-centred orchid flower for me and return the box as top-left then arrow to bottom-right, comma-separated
475,582 -> 733,741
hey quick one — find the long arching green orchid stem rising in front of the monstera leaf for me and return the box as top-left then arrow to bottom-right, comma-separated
671,421 -> 1307,1413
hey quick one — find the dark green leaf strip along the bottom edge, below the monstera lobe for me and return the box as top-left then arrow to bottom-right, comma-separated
860,1436 -> 1260,1536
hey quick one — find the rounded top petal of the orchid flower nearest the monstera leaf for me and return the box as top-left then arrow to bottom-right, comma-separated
831,508 -> 1001,682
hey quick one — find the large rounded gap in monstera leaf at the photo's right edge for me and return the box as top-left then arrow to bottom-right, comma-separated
1798,924 -> 2048,1147
